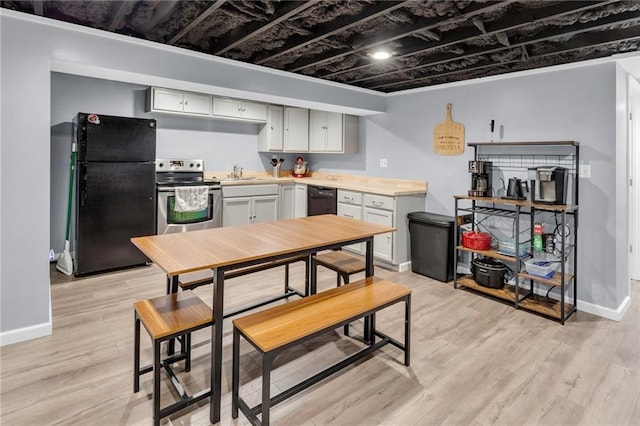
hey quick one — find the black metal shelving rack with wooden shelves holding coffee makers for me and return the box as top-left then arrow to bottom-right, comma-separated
453,141 -> 579,324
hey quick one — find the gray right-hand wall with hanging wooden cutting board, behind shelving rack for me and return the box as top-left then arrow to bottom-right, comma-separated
321,63 -> 628,311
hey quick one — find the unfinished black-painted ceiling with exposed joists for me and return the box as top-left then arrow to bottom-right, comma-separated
0,0 -> 640,92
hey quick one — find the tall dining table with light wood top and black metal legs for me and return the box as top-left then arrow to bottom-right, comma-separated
131,215 -> 395,423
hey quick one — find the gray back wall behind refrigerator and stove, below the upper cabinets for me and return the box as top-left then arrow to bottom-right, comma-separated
50,72 -> 294,253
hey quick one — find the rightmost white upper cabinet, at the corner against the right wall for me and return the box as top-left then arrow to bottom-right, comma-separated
309,110 -> 358,153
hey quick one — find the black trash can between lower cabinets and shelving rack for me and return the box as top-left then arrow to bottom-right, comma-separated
407,212 -> 455,282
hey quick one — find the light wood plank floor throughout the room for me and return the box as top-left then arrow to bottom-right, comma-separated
0,265 -> 640,426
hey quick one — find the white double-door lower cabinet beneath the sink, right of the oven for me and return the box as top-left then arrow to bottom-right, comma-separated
222,184 -> 278,226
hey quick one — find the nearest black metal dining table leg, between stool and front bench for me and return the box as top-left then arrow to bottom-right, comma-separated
209,268 -> 224,423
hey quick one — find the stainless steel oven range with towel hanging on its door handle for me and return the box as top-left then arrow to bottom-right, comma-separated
156,159 -> 222,235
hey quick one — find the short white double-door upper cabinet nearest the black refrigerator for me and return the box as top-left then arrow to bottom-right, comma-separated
147,87 -> 211,116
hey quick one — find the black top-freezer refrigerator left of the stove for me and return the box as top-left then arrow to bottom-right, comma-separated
73,113 -> 156,276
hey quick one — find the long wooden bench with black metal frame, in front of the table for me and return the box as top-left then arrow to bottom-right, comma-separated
232,277 -> 411,425
